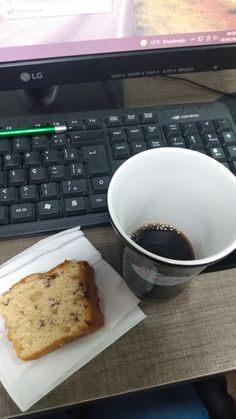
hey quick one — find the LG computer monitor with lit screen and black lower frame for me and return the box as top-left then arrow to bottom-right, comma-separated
0,0 -> 236,90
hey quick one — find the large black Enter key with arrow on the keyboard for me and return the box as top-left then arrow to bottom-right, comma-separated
82,144 -> 110,175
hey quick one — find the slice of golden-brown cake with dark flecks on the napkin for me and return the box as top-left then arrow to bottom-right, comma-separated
0,260 -> 104,360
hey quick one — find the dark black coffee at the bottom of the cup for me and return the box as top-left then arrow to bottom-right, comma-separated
130,223 -> 194,260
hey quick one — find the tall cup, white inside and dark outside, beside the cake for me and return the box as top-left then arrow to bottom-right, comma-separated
108,147 -> 236,300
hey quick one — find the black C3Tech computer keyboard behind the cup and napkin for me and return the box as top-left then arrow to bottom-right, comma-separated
0,99 -> 236,239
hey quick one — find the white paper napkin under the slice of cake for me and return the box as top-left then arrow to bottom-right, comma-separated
0,227 -> 145,411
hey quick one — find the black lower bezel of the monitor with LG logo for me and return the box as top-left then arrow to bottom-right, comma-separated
0,44 -> 236,90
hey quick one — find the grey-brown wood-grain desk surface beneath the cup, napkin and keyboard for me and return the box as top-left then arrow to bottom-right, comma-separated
0,72 -> 236,418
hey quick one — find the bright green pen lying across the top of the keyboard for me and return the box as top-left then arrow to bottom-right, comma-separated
0,125 -> 67,139
